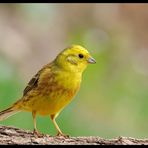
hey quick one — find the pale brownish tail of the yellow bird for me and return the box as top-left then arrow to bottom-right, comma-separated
0,106 -> 20,121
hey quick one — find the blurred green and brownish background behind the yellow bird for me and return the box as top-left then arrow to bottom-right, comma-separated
0,3 -> 148,138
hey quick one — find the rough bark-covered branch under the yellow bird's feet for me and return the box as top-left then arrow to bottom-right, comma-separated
0,126 -> 148,145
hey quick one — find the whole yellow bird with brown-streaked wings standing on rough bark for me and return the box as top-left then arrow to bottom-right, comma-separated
0,45 -> 96,136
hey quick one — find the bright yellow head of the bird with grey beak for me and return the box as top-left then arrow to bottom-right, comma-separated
55,45 -> 96,73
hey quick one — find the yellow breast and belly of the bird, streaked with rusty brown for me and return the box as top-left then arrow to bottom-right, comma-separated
40,71 -> 81,114
